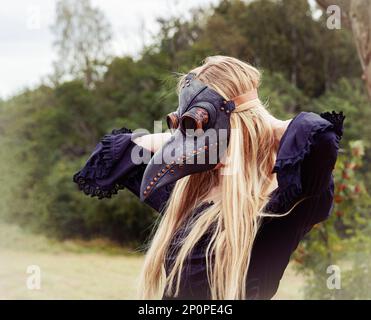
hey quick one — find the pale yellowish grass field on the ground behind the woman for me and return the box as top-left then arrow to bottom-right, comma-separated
0,224 -> 304,299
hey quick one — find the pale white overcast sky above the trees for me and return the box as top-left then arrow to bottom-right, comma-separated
0,0 -> 218,98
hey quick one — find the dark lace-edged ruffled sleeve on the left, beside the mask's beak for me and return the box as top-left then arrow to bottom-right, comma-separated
73,128 -> 171,212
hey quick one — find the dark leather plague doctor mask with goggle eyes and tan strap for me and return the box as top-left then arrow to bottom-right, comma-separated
140,73 -> 257,201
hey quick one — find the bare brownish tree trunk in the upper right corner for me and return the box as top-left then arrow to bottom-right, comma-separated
317,0 -> 371,99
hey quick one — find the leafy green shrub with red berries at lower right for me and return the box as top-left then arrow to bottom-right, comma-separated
295,141 -> 371,299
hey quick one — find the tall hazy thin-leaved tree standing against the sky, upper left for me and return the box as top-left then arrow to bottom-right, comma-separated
52,0 -> 112,86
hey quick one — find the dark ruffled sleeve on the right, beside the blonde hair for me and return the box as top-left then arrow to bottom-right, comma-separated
266,111 -> 345,213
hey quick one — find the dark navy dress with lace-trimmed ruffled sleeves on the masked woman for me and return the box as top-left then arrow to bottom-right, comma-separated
74,112 -> 344,299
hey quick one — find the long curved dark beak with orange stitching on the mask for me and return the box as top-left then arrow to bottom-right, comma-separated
140,130 -> 220,201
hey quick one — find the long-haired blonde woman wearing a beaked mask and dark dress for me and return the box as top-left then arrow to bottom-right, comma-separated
74,56 -> 344,299
